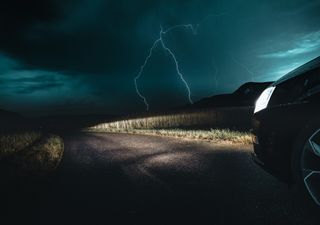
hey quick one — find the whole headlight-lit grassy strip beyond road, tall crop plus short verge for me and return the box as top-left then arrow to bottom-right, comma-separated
88,107 -> 252,144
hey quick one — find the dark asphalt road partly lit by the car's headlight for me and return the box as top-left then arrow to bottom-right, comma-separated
6,133 -> 320,225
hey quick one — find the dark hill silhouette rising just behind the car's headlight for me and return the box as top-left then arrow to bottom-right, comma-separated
189,82 -> 273,108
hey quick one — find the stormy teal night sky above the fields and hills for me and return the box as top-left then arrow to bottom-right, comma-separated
0,0 -> 320,115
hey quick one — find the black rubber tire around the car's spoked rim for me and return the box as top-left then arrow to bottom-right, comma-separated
291,120 -> 320,209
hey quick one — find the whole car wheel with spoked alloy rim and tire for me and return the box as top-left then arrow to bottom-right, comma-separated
292,121 -> 320,207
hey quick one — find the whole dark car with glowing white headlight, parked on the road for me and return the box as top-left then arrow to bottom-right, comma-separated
252,57 -> 320,206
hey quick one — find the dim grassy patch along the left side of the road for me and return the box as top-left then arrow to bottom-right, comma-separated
0,132 -> 64,175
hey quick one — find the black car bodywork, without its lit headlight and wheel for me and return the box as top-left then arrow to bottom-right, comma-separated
252,57 -> 320,183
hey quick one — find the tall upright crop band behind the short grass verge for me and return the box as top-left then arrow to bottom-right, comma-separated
89,107 -> 252,130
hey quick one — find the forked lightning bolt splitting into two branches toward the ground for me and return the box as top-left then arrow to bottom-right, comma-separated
134,13 -> 226,111
